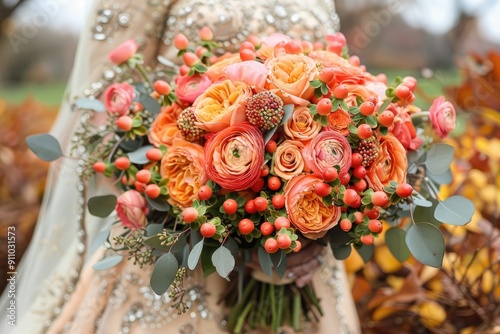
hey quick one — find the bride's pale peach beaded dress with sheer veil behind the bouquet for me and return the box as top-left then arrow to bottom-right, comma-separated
0,0 -> 359,334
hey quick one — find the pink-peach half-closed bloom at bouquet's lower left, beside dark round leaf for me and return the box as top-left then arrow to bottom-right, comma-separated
115,190 -> 148,230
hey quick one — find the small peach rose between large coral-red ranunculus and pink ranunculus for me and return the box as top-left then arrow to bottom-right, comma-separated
274,140 -> 305,180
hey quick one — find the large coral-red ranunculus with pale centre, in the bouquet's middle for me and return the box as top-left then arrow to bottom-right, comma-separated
205,122 -> 264,191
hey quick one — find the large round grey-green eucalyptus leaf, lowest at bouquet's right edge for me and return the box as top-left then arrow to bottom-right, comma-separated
405,223 -> 444,268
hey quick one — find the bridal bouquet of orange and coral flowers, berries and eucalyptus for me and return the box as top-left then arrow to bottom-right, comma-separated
27,28 -> 474,332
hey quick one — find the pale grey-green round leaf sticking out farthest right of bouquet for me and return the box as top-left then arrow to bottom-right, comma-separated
434,196 -> 475,226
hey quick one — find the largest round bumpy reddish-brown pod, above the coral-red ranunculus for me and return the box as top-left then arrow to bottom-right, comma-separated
245,90 -> 285,131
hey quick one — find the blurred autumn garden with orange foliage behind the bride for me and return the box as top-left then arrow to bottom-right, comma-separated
0,0 -> 500,334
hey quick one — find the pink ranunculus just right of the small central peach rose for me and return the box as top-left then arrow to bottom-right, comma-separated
302,130 -> 352,177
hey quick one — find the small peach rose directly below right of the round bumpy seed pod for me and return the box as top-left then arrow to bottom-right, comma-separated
284,106 -> 322,143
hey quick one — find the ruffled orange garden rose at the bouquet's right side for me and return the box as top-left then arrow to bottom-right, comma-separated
366,133 -> 408,191
